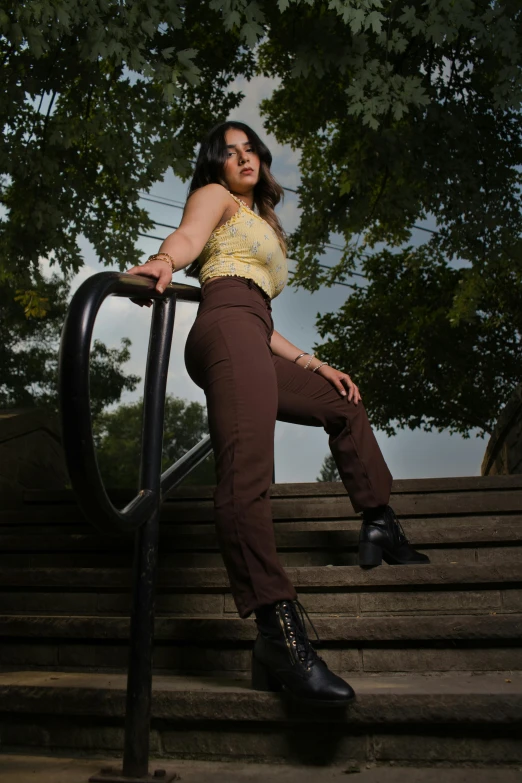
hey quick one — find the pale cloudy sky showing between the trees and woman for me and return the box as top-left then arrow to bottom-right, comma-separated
66,78 -> 487,482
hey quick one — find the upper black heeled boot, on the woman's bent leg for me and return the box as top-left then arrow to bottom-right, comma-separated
359,506 -> 430,566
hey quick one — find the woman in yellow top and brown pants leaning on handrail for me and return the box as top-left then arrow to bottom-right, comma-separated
130,122 -> 428,704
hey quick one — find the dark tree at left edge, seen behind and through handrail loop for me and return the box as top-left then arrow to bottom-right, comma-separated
0,270 -> 140,414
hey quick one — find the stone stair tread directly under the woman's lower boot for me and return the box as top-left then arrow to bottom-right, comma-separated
0,671 -> 522,724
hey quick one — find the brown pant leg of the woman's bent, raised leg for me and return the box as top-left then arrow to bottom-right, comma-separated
272,356 -> 392,511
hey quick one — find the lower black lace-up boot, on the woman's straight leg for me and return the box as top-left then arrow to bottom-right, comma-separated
252,601 -> 355,706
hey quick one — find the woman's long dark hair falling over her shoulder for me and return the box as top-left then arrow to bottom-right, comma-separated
185,120 -> 286,277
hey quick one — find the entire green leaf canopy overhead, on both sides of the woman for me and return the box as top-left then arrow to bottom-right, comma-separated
4,0 -> 522,434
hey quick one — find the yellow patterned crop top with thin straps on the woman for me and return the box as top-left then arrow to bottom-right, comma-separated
199,193 -> 288,299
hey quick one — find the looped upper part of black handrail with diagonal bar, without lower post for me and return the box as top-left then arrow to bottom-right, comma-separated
59,272 -> 212,533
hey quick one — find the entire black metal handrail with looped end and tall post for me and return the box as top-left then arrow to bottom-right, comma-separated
59,272 -> 212,781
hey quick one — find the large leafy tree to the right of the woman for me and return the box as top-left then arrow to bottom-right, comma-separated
252,0 -> 522,435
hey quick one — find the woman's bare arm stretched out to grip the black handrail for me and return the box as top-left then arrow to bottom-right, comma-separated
128,184 -> 231,293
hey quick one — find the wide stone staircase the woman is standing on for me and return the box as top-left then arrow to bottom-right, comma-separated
0,476 -> 522,766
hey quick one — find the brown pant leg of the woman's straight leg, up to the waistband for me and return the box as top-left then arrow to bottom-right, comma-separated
186,281 -> 296,617
